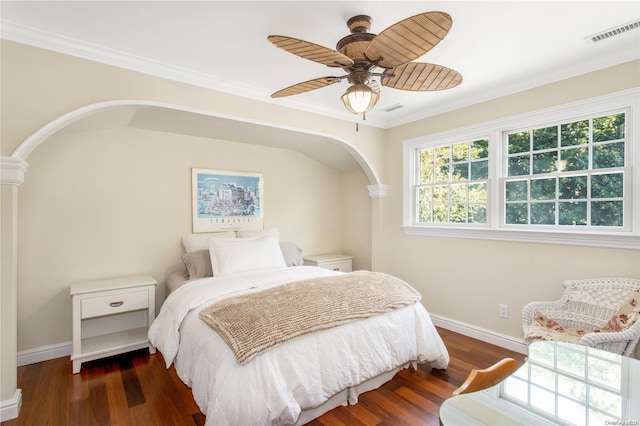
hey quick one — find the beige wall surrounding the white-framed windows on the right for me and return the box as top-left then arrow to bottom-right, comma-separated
383,61 -> 640,338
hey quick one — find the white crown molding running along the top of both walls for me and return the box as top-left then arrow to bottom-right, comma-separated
0,20 -> 640,129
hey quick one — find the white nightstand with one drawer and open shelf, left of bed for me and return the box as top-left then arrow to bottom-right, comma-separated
69,275 -> 158,374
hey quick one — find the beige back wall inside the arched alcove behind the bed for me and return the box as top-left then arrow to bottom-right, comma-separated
18,128 -> 368,351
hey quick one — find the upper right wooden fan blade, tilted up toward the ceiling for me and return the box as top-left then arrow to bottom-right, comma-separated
364,12 -> 453,68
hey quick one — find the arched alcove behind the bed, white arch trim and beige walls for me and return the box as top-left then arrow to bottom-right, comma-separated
3,100 -> 384,364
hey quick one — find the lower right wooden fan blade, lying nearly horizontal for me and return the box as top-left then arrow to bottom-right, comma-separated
382,62 -> 462,91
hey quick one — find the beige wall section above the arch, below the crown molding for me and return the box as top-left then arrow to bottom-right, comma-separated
0,40 -> 385,173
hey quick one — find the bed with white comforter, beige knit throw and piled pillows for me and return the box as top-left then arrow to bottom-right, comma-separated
149,231 -> 449,425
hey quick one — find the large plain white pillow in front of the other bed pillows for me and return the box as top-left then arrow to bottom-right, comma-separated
209,235 -> 287,277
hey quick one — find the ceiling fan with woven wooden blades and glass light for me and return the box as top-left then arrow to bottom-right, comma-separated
267,12 -> 462,119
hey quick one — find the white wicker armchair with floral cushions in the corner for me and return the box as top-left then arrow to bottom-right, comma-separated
522,278 -> 640,356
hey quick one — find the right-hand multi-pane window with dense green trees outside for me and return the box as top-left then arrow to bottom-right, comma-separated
503,112 -> 626,228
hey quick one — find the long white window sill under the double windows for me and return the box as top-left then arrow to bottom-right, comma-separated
402,226 -> 640,250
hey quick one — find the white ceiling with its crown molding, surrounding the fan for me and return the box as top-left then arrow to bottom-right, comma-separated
0,0 -> 640,128
